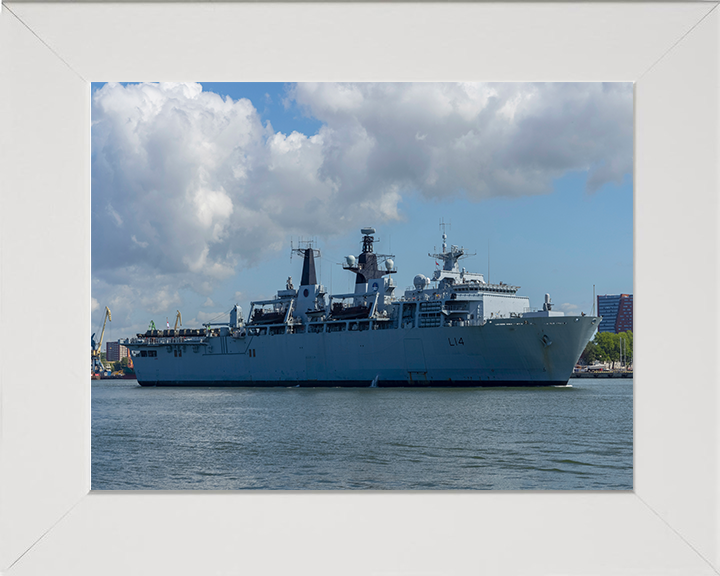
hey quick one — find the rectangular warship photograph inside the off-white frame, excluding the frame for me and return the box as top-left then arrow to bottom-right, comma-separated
91,77 -> 634,491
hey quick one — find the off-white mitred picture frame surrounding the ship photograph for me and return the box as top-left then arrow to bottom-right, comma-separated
0,2 -> 720,576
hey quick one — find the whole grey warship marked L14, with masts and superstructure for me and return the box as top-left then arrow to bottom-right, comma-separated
119,228 -> 600,387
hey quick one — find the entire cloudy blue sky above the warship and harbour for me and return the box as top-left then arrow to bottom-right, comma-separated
92,82 -> 633,341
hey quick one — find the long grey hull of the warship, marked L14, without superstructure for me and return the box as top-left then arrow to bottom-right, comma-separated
129,316 -> 597,388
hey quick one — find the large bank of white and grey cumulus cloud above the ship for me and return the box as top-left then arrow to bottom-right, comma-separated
92,83 -> 632,332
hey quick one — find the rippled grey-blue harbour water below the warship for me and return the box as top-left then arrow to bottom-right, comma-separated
92,379 -> 633,490
